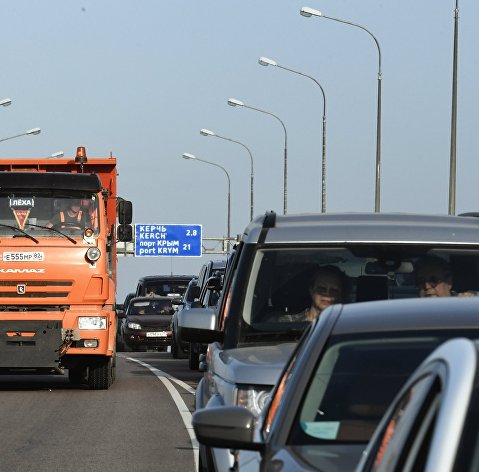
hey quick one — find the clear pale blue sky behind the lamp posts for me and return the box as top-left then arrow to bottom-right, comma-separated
0,0 -> 479,301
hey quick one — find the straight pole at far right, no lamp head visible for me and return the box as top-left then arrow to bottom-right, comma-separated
449,0 -> 459,215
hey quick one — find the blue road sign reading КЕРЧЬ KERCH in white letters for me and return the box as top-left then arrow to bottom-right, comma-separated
135,223 -> 202,257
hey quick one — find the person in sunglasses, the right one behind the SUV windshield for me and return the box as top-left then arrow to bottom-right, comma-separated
415,255 -> 476,297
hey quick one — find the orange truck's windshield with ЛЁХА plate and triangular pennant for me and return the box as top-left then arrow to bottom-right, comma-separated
0,192 -> 100,238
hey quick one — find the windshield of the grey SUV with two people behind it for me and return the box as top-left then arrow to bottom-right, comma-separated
240,244 -> 479,343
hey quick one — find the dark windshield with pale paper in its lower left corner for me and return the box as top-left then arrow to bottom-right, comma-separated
289,330 -> 478,445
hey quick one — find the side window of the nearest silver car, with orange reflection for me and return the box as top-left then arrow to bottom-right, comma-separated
367,372 -> 441,472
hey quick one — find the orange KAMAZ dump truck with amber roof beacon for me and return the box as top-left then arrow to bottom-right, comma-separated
0,147 -> 132,389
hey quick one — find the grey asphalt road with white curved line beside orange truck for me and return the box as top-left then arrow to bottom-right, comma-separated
0,352 -> 202,472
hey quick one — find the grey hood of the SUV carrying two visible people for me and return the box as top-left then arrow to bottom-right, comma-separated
215,343 -> 296,385
